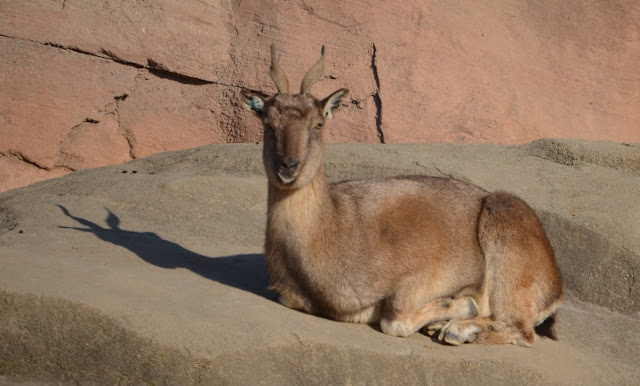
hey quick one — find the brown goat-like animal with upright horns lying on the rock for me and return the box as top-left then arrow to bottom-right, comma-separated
241,45 -> 562,346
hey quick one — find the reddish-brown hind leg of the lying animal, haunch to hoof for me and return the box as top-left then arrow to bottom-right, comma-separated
456,192 -> 561,346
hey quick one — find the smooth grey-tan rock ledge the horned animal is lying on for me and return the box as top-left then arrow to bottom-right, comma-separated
0,142 -> 640,384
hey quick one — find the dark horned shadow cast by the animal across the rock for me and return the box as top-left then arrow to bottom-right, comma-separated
57,205 -> 276,301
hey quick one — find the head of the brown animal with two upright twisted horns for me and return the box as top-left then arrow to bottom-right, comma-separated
240,44 -> 349,189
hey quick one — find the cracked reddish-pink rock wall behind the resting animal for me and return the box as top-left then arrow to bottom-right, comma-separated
0,0 -> 640,190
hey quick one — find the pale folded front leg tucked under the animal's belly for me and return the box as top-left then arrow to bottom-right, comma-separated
380,296 -> 478,337
